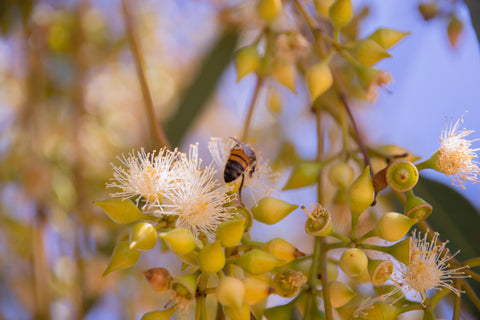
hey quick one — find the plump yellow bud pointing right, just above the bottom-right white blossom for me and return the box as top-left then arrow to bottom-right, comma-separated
375,212 -> 417,241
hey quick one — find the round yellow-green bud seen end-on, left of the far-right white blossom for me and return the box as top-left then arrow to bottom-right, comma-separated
385,160 -> 418,192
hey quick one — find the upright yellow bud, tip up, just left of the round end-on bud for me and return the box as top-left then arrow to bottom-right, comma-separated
347,166 -> 374,218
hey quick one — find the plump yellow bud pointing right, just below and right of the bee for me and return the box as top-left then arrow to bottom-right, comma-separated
252,197 -> 298,225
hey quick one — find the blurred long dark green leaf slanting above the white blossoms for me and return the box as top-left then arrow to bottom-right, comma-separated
167,30 -> 238,146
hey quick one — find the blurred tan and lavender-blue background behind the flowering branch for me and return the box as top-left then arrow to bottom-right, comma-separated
0,0 -> 480,320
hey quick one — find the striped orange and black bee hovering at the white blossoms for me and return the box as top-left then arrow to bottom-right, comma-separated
223,138 -> 257,198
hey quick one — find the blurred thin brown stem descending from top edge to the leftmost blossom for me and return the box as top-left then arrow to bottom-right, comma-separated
123,0 -> 170,148
